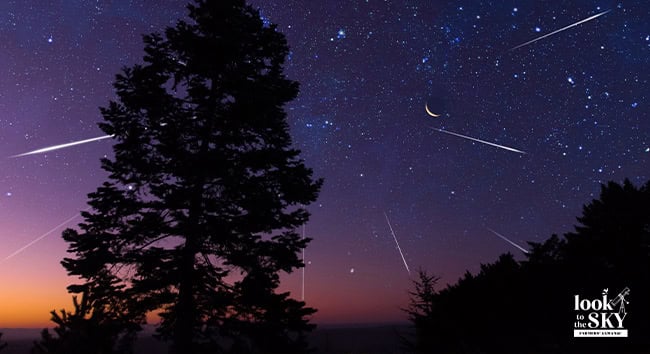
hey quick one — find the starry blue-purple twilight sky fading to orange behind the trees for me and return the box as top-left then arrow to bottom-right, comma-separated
0,0 -> 650,327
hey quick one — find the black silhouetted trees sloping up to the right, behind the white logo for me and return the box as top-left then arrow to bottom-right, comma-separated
411,180 -> 650,353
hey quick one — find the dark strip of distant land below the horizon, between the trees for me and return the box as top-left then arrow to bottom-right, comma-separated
0,325 -> 410,354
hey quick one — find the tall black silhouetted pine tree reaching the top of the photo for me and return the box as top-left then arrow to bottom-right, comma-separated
57,0 -> 322,353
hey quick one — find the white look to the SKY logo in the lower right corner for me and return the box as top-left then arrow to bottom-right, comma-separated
573,287 -> 630,337
